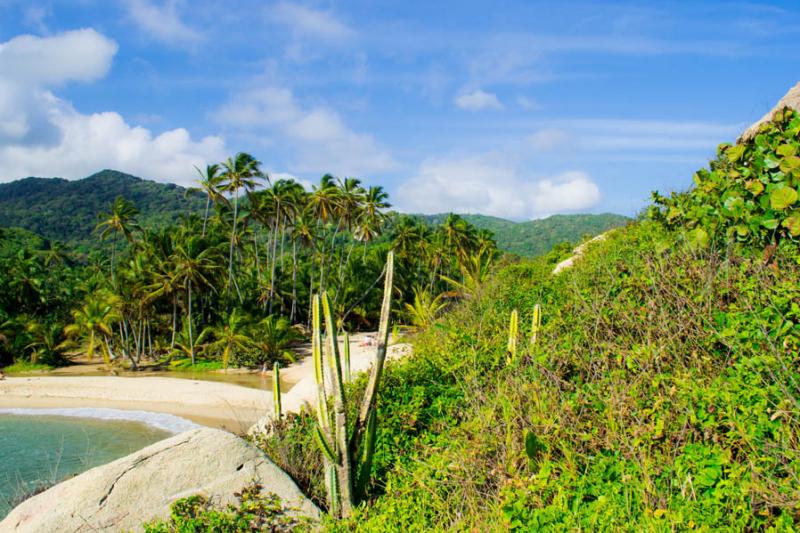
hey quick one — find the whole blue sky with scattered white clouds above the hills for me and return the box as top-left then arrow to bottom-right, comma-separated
0,0 -> 800,220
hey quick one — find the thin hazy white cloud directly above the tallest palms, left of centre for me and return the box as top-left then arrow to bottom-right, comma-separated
215,87 -> 395,176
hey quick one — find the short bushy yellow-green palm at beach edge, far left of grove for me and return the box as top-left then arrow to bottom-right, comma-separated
59,294 -> 121,368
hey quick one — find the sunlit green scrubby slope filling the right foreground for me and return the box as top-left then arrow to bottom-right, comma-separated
234,105 -> 800,531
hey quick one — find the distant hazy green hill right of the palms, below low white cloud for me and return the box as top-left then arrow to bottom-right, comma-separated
421,213 -> 630,256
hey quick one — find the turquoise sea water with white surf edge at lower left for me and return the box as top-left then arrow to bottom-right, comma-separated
0,410 -> 176,519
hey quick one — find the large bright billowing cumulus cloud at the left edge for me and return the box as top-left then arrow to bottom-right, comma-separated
0,29 -> 225,184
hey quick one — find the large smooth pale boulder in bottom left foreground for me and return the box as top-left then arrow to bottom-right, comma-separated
0,428 -> 320,533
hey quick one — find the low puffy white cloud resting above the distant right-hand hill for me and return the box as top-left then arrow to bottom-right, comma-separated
395,154 -> 600,220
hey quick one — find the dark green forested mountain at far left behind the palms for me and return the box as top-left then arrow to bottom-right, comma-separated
0,170 -> 205,247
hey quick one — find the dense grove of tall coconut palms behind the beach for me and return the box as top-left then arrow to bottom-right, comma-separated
0,154 -> 496,369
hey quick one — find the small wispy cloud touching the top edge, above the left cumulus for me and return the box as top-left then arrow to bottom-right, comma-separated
125,0 -> 203,48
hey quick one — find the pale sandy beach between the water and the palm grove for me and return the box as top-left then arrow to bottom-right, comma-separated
0,334 -> 410,434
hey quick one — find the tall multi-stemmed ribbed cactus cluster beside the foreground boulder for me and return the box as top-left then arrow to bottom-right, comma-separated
311,252 -> 394,517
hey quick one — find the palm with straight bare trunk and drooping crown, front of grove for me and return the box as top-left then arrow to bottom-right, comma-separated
172,235 -> 219,365
